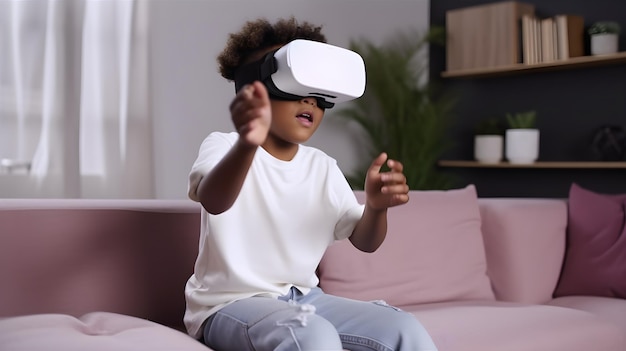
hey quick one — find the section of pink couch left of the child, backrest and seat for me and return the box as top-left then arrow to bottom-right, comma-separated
0,199 -> 207,351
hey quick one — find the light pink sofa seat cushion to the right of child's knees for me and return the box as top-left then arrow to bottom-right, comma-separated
404,301 -> 626,351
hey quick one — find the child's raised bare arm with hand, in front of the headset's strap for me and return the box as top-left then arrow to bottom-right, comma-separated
197,82 -> 272,214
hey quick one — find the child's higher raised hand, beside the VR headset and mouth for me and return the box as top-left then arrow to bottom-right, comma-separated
230,81 -> 272,146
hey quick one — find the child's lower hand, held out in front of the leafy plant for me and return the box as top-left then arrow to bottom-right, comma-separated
365,152 -> 409,210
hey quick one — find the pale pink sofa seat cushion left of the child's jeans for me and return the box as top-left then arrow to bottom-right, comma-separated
0,312 -> 208,351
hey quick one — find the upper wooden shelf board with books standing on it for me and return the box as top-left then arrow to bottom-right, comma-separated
441,51 -> 626,78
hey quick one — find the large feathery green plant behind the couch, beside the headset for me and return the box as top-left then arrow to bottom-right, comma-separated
338,27 -> 454,190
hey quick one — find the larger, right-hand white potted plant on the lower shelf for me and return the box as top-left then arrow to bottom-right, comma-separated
505,111 -> 539,164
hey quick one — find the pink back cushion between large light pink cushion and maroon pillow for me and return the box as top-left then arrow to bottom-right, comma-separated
479,198 -> 567,303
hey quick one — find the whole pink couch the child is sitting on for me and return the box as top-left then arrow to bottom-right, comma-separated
0,186 -> 626,351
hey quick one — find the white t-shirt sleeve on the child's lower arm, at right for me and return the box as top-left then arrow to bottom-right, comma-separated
329,164 -> 365,240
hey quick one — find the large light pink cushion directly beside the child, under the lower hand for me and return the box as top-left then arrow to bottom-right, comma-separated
319,185 -> 494,306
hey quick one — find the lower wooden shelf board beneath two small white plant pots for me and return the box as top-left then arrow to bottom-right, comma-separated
438,160 -> 626,169
